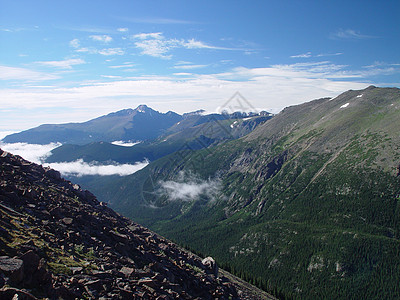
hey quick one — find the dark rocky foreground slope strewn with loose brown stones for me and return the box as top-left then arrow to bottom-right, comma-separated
0,150 -> 270,299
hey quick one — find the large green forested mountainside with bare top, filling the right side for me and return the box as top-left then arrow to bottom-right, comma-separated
96,87 -> 400,299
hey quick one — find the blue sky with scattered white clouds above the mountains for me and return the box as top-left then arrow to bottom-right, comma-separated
0,0 -> 400,135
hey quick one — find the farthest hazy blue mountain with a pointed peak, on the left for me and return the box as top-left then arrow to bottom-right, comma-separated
3,105 -> 182,145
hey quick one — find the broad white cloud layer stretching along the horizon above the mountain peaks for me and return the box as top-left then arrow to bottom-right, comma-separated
0,62 -> 371,125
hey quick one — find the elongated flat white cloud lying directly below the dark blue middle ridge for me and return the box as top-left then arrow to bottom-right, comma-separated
45,159 -> 149,176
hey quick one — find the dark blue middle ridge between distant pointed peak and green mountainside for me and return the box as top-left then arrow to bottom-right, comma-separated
46,115 -> 271,166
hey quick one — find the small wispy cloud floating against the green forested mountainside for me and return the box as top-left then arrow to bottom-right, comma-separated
156,172 -> 221,201
